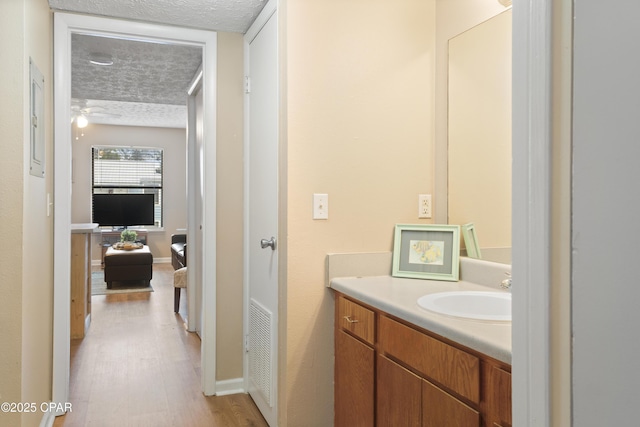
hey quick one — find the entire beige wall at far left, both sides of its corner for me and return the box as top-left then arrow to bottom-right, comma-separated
0,0 -> 53,426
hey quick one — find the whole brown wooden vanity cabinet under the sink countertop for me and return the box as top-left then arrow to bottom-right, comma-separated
335,293 -> 511,427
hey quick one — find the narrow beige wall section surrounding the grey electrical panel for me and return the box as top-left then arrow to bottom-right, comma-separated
22,0 -> 53,426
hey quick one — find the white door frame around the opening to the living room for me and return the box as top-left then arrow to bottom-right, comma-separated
52,13 -> 217,415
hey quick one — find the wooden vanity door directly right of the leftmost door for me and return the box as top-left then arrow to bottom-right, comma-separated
376,355 -> 422,427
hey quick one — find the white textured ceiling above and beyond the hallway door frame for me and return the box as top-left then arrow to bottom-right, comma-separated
49,0 -> 267,127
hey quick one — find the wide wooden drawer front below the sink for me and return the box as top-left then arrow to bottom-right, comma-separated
378,316 -> 480,403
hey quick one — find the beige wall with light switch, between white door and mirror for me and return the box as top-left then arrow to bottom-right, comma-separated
280,0 -> 438,426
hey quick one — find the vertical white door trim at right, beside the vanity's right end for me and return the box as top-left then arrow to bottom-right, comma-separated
512,0 -> 552,426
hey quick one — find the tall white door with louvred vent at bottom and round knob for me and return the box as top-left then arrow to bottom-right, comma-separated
245,4 -> 278,426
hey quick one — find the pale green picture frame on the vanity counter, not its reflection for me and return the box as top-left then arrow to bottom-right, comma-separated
391,224 -> 460,281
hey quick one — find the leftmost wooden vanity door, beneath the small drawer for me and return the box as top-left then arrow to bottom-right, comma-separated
335,330 -> 375,427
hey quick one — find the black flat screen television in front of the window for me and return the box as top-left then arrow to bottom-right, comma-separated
93,194 -> 155,227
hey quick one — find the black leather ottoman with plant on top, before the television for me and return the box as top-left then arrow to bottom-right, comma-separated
104,245 -> 153,289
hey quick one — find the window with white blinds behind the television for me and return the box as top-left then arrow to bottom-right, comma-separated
92,146 -> 163,227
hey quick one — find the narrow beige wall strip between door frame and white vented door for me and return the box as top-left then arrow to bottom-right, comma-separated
216,33 -> 244,381
